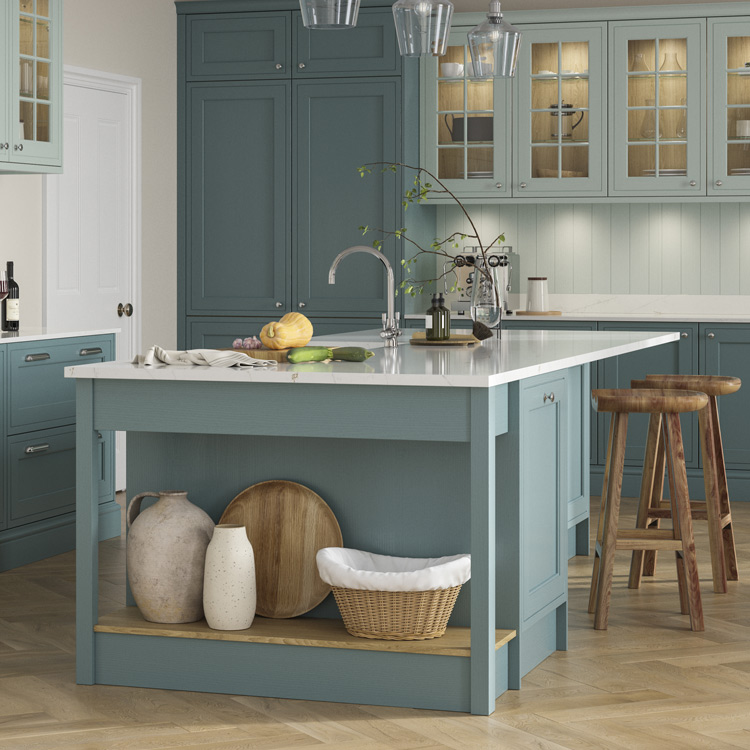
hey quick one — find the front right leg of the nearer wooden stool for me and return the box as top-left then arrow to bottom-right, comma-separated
665,414 -> 704,631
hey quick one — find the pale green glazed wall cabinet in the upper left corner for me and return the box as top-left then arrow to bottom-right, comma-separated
0,0 -> 63,173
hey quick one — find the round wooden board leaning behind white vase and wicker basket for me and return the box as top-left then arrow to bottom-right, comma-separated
219,479 -> 343,618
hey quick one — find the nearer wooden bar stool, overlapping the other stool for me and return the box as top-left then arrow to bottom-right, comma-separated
589,389 -> 708,630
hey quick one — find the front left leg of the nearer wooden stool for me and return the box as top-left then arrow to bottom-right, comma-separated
594,413 -> 628,630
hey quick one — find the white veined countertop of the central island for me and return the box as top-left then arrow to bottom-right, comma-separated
65,330 -> 679,388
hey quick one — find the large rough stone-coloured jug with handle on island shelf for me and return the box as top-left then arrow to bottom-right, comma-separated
127,490 -> 214,623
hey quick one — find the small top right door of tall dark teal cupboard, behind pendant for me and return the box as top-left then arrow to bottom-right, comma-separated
292,8 -> 401,78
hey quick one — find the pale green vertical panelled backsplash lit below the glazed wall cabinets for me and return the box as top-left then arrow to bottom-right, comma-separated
437,203 -> 750,294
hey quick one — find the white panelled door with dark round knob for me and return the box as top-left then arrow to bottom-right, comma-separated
44,67 -> 140,489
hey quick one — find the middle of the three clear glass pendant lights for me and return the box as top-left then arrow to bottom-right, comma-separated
393,0 -> 453,57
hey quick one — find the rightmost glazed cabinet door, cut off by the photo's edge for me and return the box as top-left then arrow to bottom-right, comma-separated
708,18 -> 750,194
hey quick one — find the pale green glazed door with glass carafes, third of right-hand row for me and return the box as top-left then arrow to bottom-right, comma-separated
610,19 -> 706,195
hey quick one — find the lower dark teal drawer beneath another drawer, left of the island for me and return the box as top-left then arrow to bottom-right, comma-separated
8,427 -> 76,527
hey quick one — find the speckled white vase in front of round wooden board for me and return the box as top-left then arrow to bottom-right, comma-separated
203,523 -> 256,630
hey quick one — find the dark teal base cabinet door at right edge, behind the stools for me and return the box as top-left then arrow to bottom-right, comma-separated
700,323 -> 750,468
